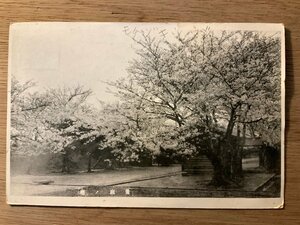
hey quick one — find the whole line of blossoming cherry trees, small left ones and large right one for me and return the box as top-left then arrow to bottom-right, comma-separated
11,29 -> 280,186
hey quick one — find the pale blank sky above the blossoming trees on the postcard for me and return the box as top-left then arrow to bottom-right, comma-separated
9,23 -> 282,104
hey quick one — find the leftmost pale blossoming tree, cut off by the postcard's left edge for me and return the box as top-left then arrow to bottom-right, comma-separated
10,77 -> 50,155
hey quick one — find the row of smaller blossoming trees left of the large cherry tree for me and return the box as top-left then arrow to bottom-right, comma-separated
11,77 -> 155,172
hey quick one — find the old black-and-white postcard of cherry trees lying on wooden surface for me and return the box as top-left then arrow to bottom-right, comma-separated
7,22 -> 285,208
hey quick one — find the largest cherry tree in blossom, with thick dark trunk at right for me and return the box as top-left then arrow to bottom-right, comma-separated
111,29 -> 280,185
